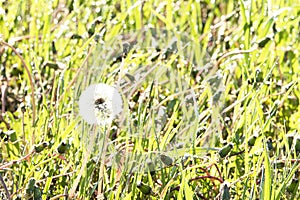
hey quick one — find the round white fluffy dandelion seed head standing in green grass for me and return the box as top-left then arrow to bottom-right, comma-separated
79,83 -> 123,126
